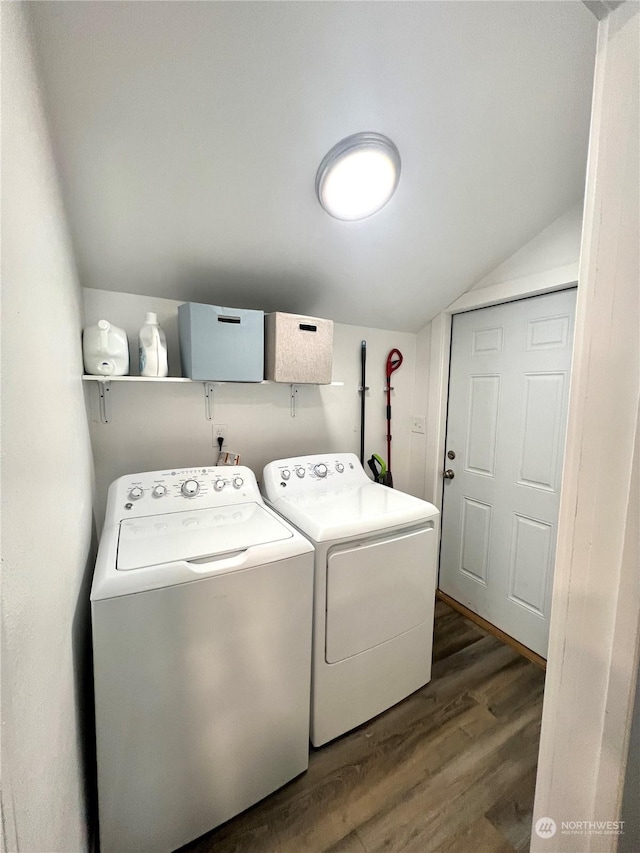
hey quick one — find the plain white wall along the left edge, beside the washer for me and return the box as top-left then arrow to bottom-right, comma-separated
0,3 -> 92,853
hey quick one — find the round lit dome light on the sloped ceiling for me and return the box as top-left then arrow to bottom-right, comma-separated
316,133 -> 400,221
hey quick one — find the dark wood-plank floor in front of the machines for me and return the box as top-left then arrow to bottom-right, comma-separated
181,601 -> 544,853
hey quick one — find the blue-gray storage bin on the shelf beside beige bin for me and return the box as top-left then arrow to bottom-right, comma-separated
178,302 -> 264,382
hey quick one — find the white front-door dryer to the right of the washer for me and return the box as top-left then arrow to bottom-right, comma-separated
262,453 -> 439,746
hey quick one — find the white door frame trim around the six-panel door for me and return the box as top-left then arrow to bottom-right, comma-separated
425,261 -> 578,512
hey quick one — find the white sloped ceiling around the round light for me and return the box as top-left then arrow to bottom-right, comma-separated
27,0 -> 597,331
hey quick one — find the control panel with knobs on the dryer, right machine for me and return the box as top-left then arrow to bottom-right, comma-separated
262,453 -> 371,501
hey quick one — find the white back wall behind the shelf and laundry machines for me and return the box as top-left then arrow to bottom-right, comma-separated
84,289 -> 425,527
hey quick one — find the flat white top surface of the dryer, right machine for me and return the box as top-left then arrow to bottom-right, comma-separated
273,482 -> 439,542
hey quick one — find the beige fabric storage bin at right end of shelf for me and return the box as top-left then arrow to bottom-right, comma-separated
264,311 -> 333,385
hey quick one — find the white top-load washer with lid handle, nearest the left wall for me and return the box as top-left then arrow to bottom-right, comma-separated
91,466 -> 313,853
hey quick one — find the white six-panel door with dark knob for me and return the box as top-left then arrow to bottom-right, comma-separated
439,290 -> 576,657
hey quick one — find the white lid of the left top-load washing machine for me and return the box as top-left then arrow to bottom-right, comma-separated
116,502 -> 293,572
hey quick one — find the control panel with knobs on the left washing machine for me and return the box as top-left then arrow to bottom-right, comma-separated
106,465 -> 262,522
